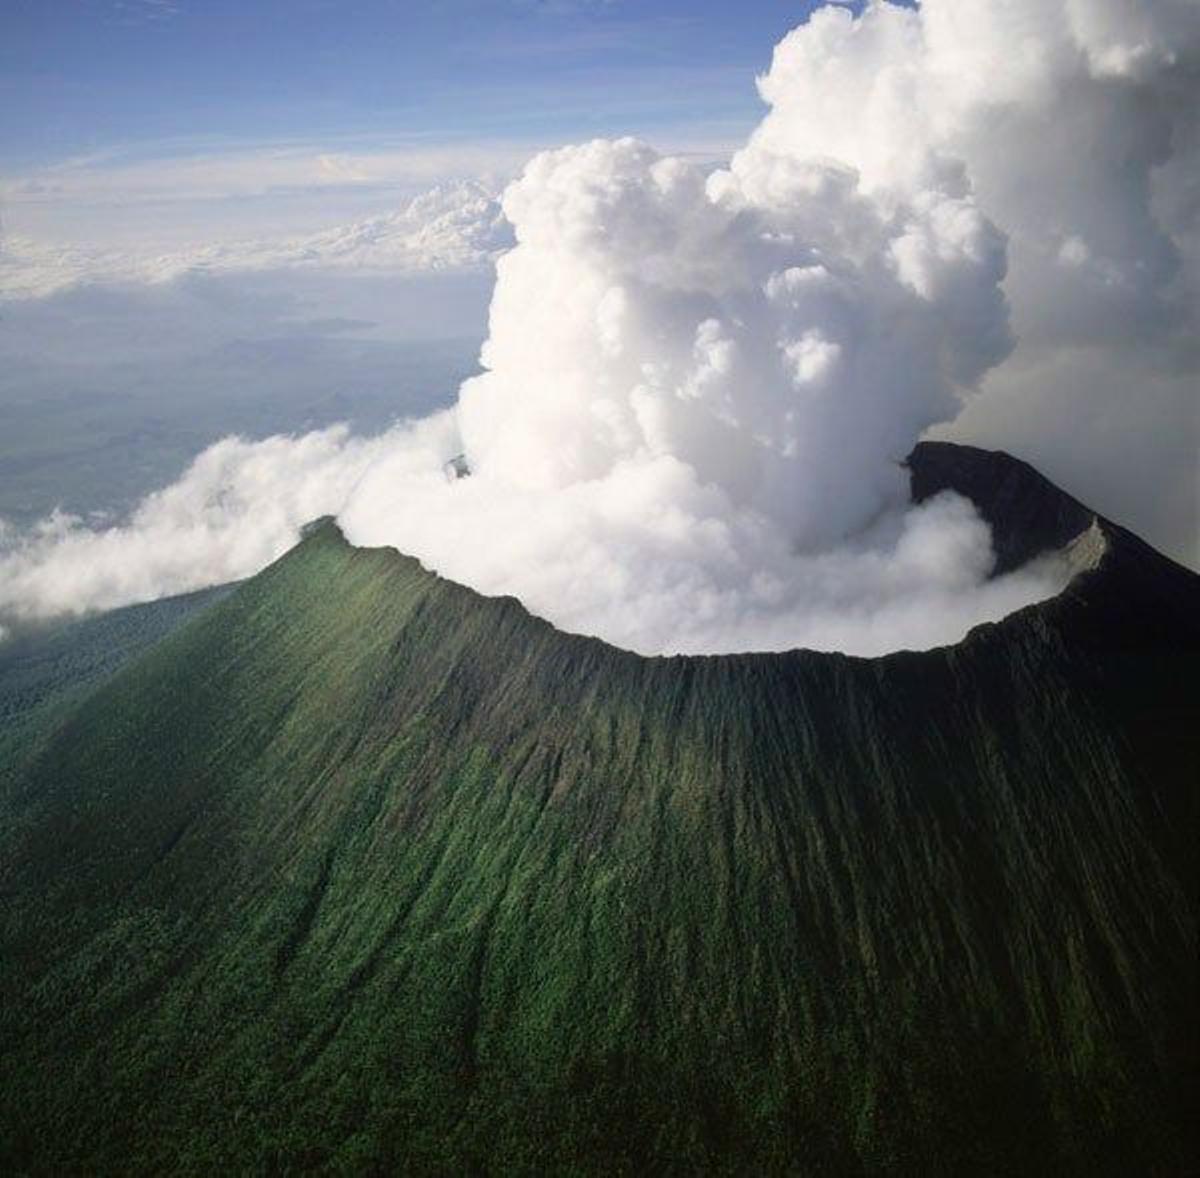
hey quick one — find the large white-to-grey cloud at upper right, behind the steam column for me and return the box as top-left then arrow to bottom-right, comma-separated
734,0 -> 1200,563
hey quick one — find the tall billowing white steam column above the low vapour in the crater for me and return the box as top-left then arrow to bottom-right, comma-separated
458,132 -> 1008,548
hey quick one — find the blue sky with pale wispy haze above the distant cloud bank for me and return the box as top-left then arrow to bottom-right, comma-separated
0,0 -> 864,251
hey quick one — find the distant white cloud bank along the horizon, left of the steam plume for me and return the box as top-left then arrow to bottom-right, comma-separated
0,180 -> 512,299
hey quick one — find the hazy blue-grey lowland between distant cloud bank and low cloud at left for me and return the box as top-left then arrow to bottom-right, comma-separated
0,278 -> 486,525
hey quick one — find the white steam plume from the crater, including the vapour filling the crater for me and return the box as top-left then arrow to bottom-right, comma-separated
342,130 -> 1044,650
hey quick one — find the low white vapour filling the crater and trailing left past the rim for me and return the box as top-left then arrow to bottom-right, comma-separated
0,414 -> 1067,654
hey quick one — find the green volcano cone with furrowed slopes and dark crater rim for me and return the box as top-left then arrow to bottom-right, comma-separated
0,445 -> 1200,1174
